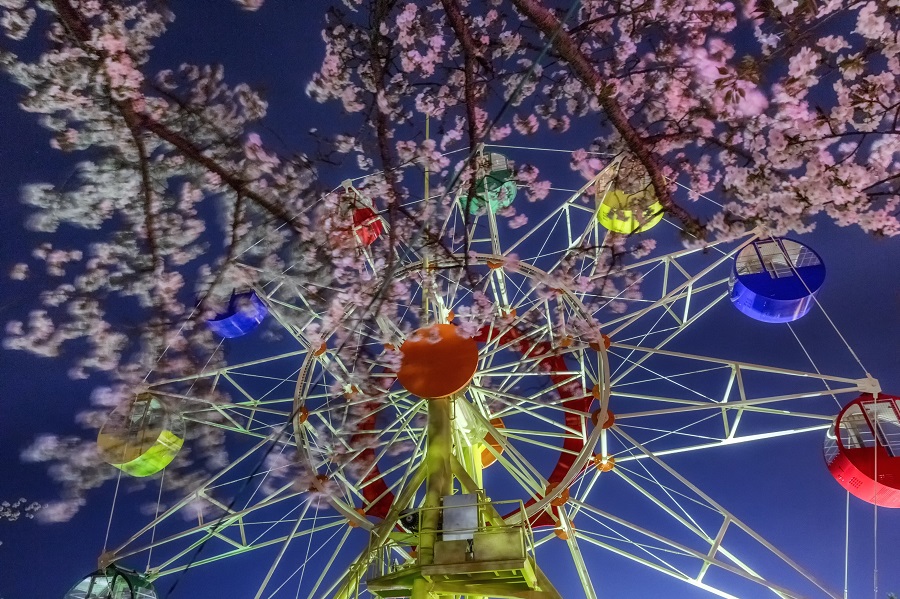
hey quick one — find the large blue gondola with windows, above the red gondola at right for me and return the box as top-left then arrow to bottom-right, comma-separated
731,237 -> 825,322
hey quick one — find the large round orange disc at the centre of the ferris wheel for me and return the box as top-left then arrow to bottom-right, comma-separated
397,324 -> 478,399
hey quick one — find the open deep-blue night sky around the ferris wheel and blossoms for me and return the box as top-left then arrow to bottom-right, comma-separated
0,0 -> 900,599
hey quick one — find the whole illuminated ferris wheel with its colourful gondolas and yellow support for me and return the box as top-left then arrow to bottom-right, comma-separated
67,149 -> 900,599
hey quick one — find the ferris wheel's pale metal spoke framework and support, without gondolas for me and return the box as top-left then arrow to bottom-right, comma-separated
96,154 -> 877,599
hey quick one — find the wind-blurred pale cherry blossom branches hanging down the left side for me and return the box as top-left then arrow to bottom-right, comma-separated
0,0 -> 318,519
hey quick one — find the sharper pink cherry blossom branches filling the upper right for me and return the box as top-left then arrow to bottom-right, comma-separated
309,0 -> 900,235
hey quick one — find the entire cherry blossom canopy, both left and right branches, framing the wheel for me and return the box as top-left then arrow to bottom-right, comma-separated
0,0 -> 900,519
